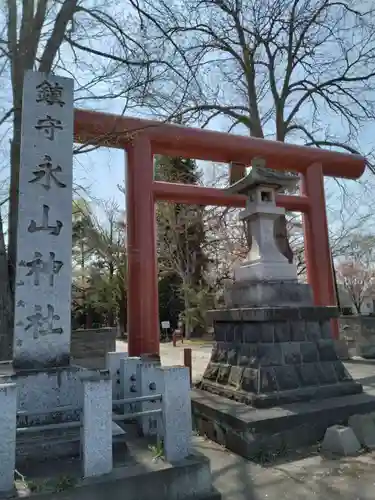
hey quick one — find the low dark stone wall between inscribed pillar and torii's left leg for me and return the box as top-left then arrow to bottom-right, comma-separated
71,328 -> 117,360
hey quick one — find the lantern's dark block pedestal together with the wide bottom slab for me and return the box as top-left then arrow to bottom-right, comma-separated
192,306 -> 375,458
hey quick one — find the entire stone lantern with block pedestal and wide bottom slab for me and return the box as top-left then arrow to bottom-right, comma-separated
193,166 -> 375,459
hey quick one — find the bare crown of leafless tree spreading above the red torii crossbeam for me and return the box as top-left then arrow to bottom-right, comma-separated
137,0 -> 375,156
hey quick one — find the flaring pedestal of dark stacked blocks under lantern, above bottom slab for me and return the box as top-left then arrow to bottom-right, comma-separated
201,306 -> 362,408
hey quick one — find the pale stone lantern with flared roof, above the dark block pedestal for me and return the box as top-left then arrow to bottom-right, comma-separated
224,166 -> 312,307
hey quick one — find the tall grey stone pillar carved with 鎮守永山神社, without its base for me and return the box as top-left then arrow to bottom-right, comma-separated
13,71 -> 73,369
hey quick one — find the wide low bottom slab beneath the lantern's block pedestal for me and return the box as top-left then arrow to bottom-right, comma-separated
192,389 -> 375,461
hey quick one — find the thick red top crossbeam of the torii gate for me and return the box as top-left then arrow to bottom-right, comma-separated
74,109 -> 365,179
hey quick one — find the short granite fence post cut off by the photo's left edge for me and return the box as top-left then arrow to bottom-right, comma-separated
0,383 -> 17,497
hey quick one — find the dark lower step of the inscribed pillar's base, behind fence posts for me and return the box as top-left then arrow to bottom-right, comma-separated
16,422 -> 126,466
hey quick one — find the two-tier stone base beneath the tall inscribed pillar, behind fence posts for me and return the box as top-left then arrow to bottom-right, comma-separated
0,363 -> 126,467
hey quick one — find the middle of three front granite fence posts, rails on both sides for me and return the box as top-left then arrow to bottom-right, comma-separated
81,370 -> 113,477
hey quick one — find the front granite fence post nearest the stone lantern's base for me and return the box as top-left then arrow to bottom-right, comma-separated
157,366 -> 192,462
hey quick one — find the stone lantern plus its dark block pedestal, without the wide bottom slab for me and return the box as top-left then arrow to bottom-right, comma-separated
200,164 -> 362,408
